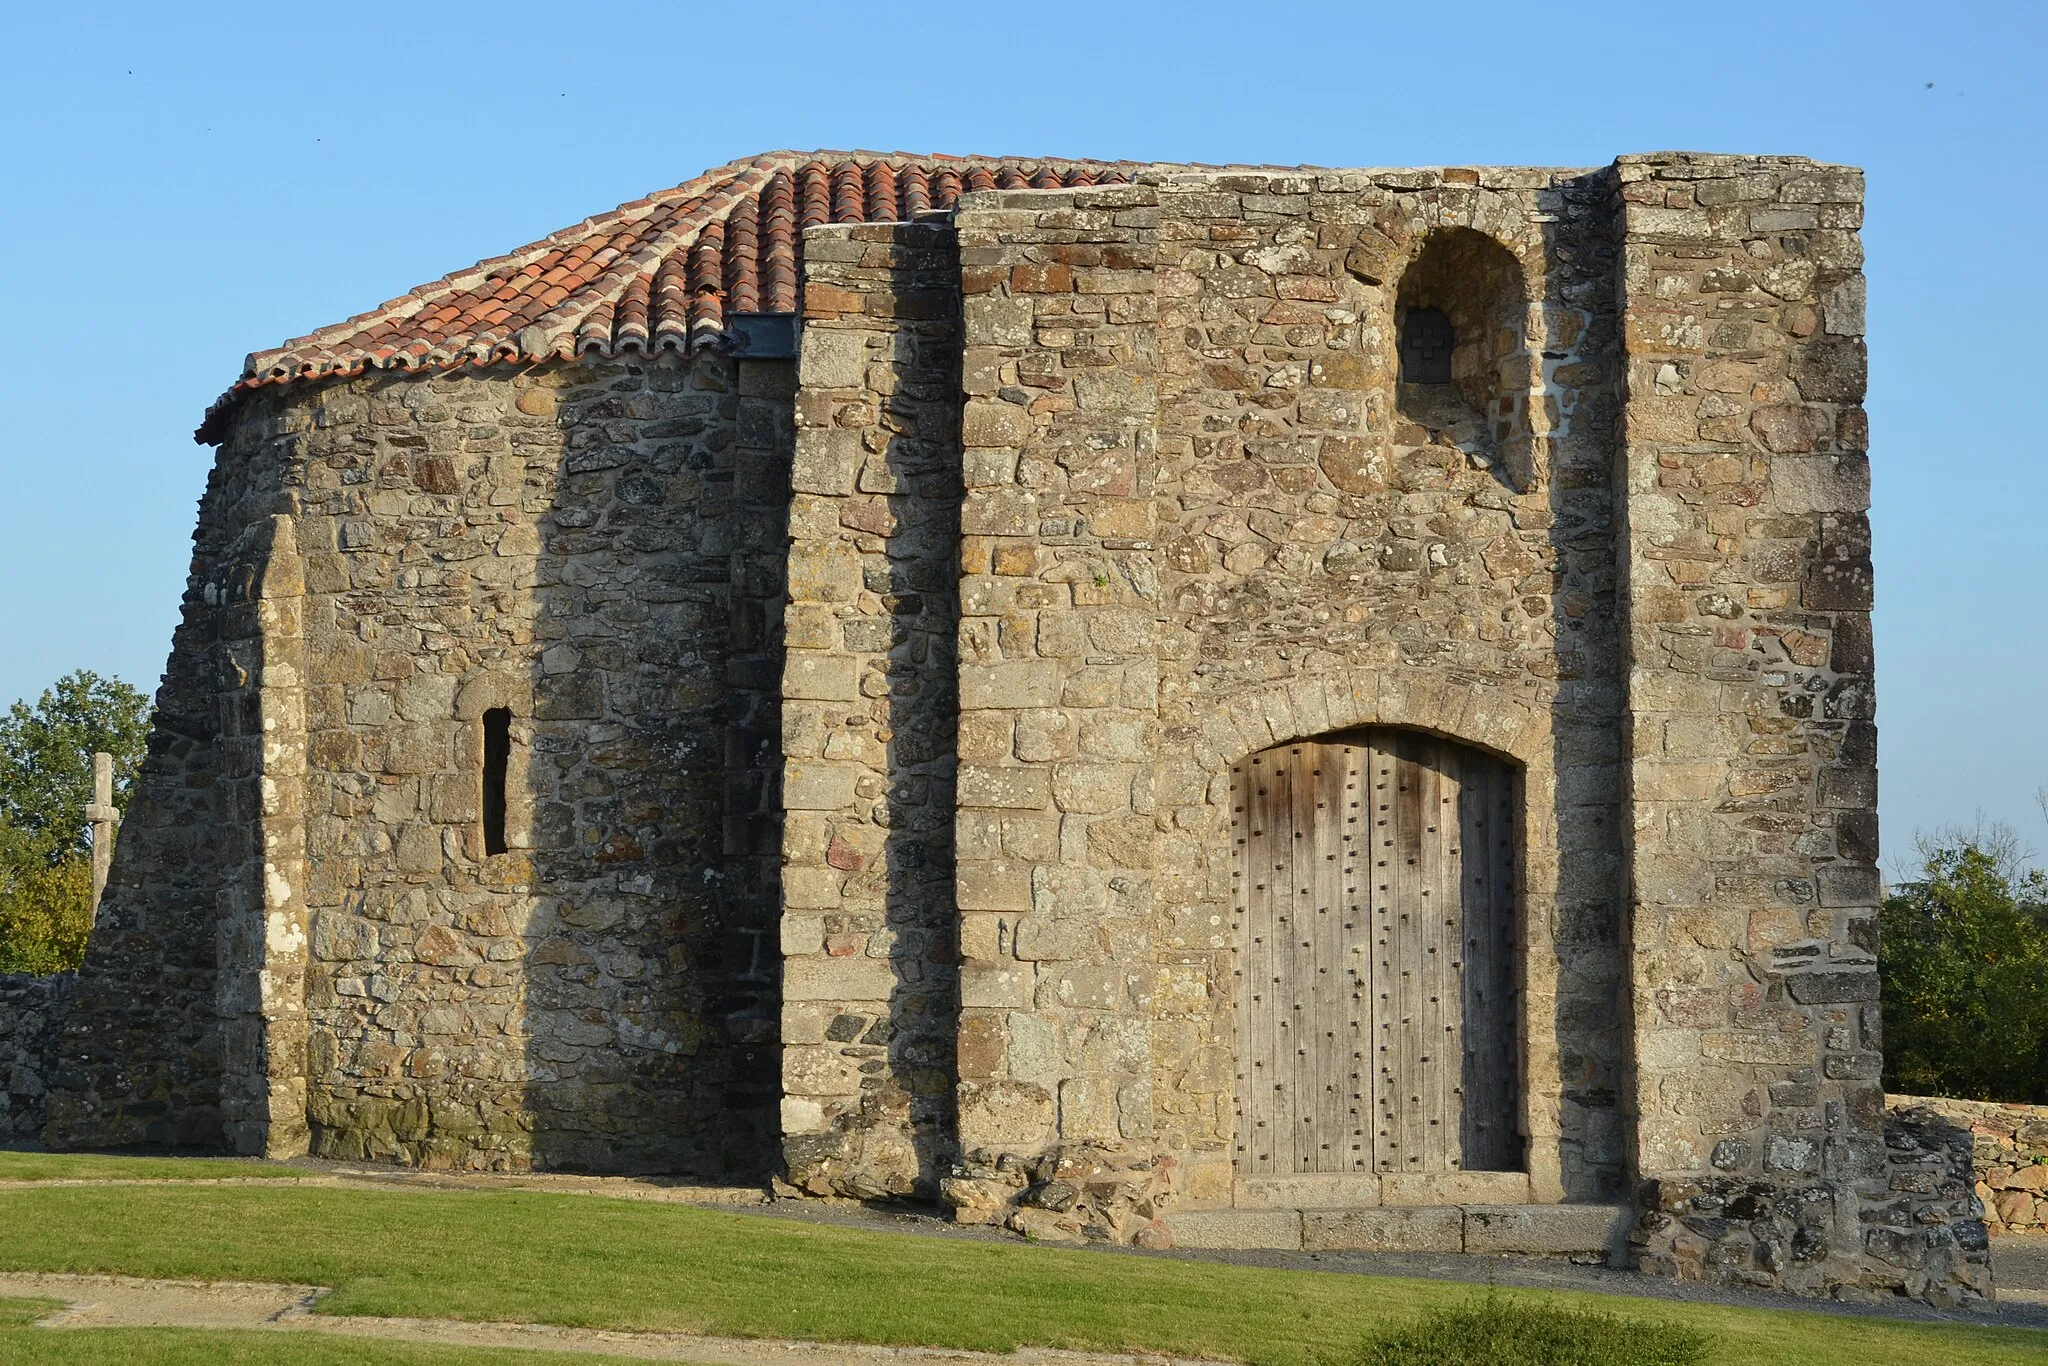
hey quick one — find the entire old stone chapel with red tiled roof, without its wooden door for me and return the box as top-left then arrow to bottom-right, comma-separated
10,154 -> 1989,1303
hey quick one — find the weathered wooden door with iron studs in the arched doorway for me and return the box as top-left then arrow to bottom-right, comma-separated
1233,729 -> 1524,1178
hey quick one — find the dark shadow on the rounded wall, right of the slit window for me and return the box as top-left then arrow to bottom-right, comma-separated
509,354 -> 793,1180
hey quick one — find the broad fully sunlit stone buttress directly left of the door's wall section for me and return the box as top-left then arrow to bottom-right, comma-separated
948,186 -> 1159,1239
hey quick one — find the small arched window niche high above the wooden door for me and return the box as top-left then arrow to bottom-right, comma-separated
1391,227 -> 1536,492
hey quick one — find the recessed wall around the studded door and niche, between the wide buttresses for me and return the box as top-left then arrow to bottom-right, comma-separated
1155,170 -> 1624,1204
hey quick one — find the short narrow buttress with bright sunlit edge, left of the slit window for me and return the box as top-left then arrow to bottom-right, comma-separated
217,514 -> 307,1157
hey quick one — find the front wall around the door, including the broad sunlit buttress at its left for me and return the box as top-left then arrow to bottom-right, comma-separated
942,172 -> 1626,1219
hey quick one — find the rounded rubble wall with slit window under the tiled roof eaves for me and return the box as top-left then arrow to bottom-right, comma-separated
223,358 -> 788,1173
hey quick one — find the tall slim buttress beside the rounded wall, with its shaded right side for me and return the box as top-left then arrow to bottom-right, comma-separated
782,223 -> 961,1198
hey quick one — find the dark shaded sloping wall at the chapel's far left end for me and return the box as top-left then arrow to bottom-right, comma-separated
45,410 -> 311,1147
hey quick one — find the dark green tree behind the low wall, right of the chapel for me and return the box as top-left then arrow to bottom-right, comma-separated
1878,836 -> 2048,1104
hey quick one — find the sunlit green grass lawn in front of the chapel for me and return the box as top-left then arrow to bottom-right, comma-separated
0,1186 -> 2048,1366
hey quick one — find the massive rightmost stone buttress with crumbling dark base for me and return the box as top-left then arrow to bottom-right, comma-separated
1618,154 -> 1966,1294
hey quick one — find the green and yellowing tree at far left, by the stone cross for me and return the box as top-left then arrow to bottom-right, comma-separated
0,670 -> 150,973
